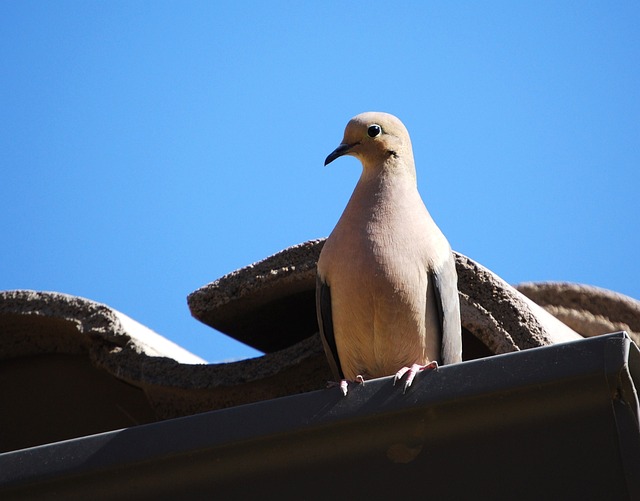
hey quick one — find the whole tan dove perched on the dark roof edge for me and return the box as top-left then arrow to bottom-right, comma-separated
316,112 -> 462,396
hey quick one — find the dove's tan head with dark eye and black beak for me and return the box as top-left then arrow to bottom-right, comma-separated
324,111 -> 413,170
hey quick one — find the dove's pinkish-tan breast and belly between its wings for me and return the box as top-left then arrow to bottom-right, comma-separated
318,174 -> 450,378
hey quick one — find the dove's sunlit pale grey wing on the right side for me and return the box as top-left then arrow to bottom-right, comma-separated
432,252 -> 462,364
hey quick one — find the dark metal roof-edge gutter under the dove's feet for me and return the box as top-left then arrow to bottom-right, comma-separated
0,333 -> 640,501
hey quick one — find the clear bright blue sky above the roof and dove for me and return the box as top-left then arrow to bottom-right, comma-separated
0,0 -> 640,361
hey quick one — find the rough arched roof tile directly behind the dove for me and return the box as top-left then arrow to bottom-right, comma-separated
188,240 -> 579,353
